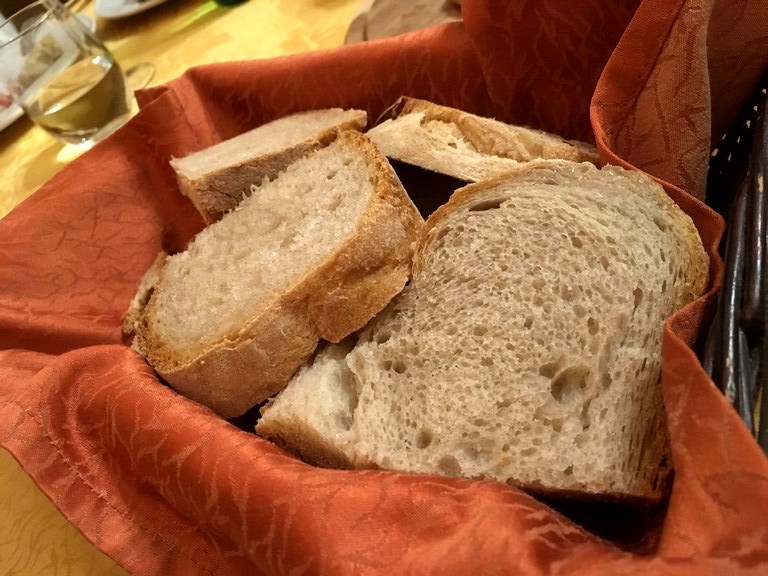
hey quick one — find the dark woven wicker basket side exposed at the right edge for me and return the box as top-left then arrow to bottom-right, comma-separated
702,75 -> 768,453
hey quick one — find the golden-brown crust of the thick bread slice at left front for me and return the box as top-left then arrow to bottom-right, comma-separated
136,131 -> 423,418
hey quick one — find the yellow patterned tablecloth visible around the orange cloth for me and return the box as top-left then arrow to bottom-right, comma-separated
0,0 -> 361,576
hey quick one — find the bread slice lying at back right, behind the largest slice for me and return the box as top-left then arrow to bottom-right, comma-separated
368,97 -> 599,182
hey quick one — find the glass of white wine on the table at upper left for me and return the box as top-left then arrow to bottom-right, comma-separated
0,0 -> 132,144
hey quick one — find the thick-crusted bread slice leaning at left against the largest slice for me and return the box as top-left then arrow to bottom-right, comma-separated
133,132 -> 423,418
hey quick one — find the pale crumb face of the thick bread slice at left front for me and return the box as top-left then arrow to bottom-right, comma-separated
153,146 -> 374,351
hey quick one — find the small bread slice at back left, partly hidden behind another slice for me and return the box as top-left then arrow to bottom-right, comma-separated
171,108 -> 368,224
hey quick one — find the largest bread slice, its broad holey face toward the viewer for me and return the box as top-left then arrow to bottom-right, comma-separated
256,160 -> 708,500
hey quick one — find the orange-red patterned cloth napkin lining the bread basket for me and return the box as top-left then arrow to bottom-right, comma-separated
0,0 -> 768,575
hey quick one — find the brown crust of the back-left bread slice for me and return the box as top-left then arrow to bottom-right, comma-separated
171,110 -> 368,224
